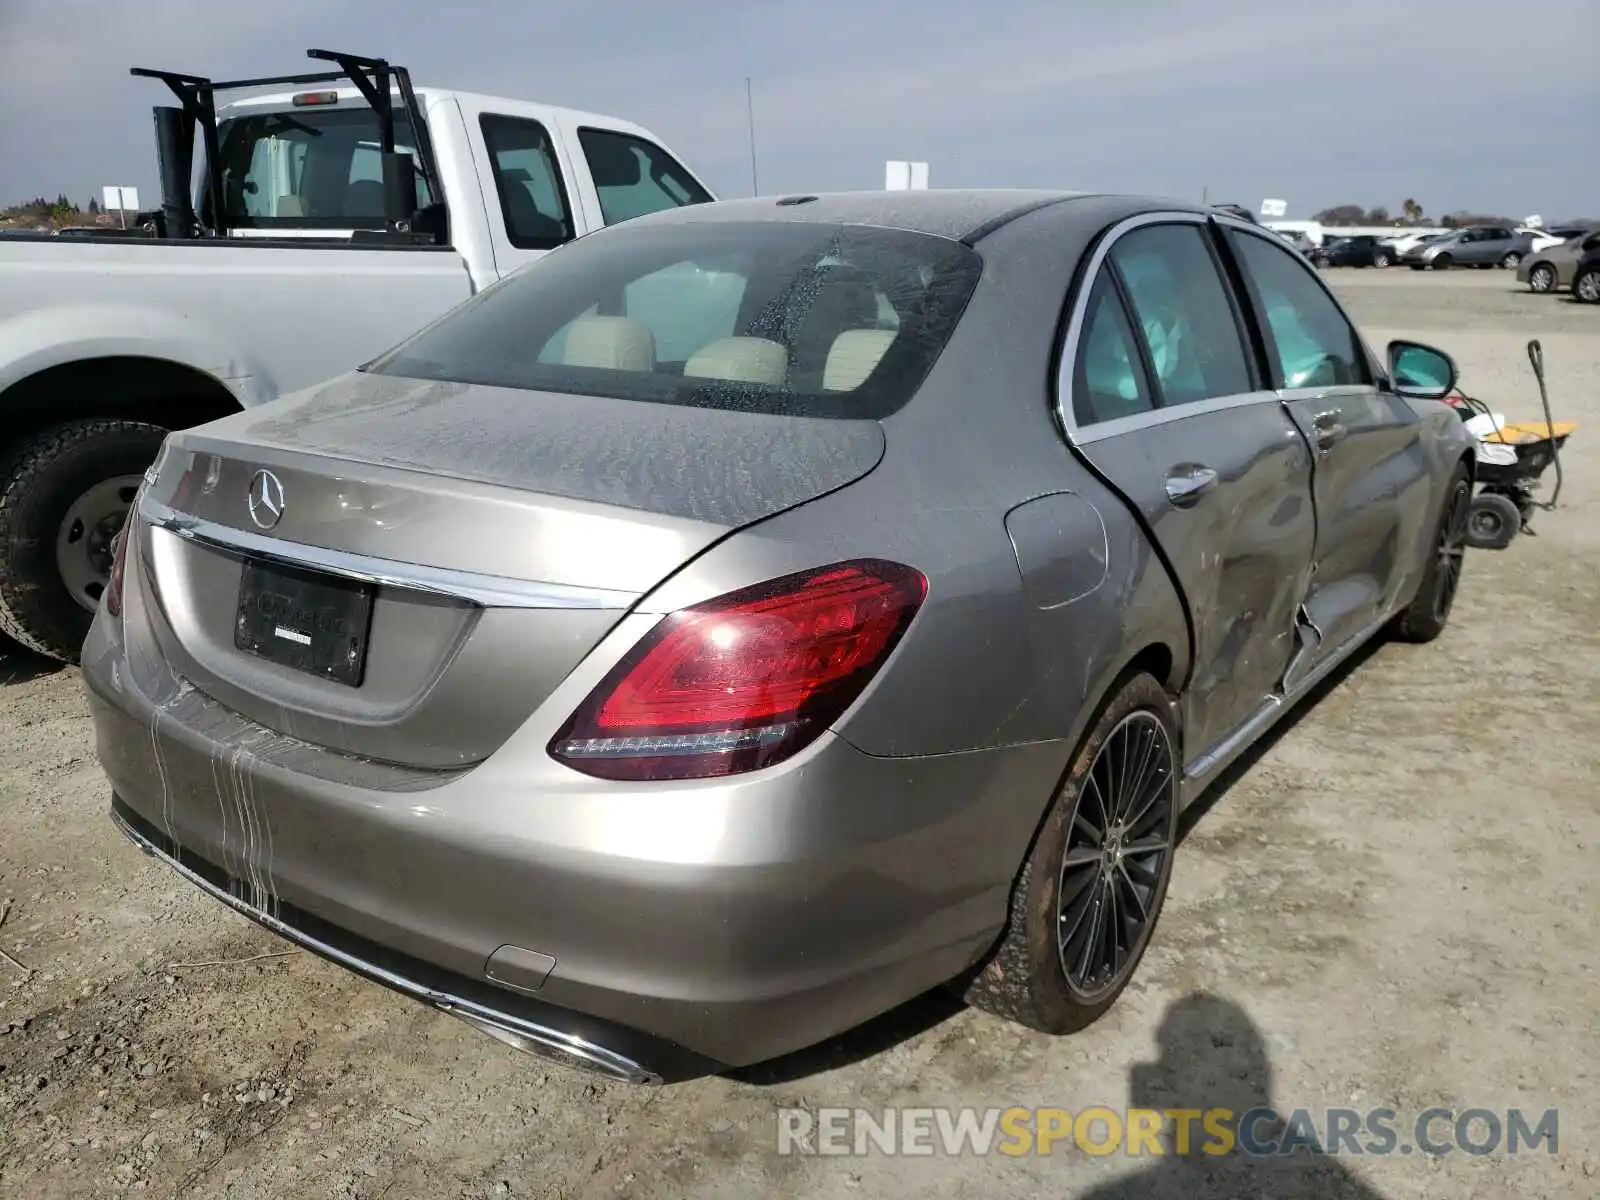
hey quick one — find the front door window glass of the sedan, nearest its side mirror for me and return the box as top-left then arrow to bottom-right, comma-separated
1229,230 -> 1371,387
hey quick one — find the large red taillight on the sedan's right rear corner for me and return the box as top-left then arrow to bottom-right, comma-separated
550,558 -> 928,779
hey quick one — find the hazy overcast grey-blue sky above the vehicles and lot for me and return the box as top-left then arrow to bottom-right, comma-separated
0,0 -> 1600,219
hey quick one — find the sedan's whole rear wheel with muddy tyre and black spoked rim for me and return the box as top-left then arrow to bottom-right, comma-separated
965,674 -> 1179,1034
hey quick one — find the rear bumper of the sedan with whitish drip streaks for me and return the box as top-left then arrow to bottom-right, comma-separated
83,618 -> 1066,1080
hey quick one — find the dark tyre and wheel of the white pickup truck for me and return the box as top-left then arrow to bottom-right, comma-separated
0,421 -> 166,662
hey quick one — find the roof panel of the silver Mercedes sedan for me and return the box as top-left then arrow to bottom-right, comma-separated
627,187 -> 1214,242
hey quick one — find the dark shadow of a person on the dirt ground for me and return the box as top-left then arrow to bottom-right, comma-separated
1082,992 -> 1382,1200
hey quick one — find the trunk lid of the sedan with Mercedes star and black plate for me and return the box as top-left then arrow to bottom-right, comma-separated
139,374 -> 883,768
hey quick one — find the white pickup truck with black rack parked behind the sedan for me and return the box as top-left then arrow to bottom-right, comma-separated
0,51 -> 712,661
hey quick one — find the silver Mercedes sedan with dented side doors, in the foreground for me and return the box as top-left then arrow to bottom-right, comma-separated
83,190 -> 1474,1082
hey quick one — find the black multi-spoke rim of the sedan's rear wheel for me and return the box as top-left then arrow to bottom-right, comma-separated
1056,710 -> 1176,1003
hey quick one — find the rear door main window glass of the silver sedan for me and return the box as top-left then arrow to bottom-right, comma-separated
1110,224 -> 1254,406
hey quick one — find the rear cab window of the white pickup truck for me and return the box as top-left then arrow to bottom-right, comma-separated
218,102 -> 432,229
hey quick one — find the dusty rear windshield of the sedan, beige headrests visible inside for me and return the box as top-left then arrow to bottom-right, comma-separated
365,221 -> 981,418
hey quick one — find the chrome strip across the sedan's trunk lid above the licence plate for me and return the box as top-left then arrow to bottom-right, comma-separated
139,494 -> 638,610
